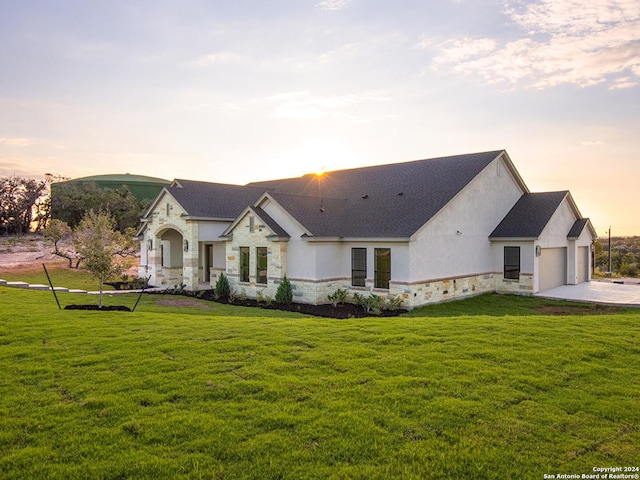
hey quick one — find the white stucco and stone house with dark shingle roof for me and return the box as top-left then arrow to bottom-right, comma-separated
138,150 -> 596,307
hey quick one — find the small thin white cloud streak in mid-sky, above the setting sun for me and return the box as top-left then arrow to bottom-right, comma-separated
269,91 -> 389,119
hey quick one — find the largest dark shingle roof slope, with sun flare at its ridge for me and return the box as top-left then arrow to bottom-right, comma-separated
248,150 -> 516,238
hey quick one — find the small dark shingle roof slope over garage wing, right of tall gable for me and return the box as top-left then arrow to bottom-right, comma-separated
489,191 -> 569,238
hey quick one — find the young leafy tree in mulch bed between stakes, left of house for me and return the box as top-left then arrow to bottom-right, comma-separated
73,210 -> 136,308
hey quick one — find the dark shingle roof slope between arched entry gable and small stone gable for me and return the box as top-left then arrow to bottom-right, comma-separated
167,180 -> 264,220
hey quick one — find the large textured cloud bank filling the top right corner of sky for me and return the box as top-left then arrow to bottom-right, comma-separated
430,0 -> 640,89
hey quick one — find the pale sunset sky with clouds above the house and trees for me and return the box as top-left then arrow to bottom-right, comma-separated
0,0 -> 640,236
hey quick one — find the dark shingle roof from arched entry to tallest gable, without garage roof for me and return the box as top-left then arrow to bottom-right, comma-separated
145,150 -> 529,239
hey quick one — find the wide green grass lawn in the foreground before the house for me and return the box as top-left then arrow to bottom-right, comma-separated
0,287 -> 640,479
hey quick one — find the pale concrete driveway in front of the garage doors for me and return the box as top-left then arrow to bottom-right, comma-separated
536,279 -> 640,308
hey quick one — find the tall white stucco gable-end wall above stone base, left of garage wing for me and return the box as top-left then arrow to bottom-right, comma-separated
409,159 -> 523,282
